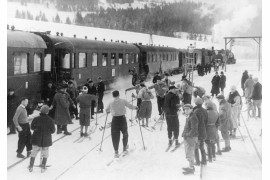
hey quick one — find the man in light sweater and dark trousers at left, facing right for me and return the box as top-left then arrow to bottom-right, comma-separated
13,97 -> 32,158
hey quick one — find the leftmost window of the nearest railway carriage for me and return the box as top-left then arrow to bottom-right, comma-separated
13,53 -> 29,75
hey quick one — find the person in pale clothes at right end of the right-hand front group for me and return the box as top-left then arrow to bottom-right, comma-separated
227,85 -> 242,138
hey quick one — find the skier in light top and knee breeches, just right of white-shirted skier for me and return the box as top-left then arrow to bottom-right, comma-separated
138,84 -> 155,127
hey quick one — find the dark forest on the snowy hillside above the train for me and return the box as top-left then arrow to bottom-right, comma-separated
11,0 -> 214,40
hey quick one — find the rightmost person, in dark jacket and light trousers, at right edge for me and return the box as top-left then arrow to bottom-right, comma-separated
251,77 -> 262,118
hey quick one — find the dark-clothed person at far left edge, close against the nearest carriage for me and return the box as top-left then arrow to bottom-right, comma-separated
7,88 -> 19,135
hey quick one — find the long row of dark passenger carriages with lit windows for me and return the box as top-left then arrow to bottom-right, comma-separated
7,29 -> 225,100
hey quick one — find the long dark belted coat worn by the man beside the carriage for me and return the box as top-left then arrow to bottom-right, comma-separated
53,91 -> 72,125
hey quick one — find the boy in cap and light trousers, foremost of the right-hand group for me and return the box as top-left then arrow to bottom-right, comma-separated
182,104 -> 198,175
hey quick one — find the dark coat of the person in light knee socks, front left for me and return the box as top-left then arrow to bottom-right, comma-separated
31,113 -> 55,147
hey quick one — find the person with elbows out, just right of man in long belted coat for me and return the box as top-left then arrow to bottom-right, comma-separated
76,86 -> 98,137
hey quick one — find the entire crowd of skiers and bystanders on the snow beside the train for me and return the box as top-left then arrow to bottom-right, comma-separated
8,65 -> 262,175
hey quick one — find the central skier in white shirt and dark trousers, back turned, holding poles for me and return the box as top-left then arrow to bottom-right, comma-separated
106,91 -> 138,157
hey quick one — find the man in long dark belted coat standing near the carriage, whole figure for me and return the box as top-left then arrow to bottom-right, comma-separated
50,84 -> 75,135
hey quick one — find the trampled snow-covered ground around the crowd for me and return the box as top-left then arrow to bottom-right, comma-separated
7,60 -> 264,180
